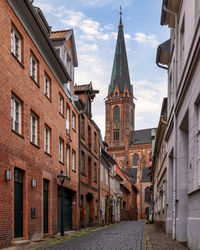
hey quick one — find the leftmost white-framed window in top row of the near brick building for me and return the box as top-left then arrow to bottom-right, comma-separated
11,26 -> 22,62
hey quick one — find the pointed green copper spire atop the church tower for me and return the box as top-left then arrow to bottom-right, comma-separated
109,6 -> 133,94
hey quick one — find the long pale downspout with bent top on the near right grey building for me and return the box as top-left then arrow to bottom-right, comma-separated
163,5 -> 178,240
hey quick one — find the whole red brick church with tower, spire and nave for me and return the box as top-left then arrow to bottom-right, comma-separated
105,13 -> 154,218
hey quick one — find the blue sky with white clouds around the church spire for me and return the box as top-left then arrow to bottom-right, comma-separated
34,0 -> 169,138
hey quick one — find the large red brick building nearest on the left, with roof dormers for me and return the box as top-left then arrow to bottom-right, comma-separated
0,0 -> 79,247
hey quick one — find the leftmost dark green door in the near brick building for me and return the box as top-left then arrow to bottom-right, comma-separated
14,169 -> 23,238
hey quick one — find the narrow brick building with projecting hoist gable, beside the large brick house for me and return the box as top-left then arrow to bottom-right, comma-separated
74,83 -> 100,227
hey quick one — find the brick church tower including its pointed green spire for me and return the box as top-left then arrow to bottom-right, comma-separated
105,11 -> 135,150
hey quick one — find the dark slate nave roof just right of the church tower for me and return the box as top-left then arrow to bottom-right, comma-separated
130,128 -> 155,145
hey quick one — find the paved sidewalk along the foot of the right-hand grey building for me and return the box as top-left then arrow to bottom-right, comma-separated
145,224 -> 186,250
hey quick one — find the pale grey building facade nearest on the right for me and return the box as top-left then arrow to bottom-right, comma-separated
158,0 -> 200,249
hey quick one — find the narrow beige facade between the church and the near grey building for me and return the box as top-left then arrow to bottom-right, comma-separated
152,98 -> 167,232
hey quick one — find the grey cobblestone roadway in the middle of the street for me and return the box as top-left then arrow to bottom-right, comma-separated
43,221 -> 145,250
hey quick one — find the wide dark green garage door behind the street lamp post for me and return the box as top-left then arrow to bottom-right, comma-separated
58,187 -> 72,232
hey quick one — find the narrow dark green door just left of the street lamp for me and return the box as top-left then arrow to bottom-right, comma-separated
43,179 -> 49,233
